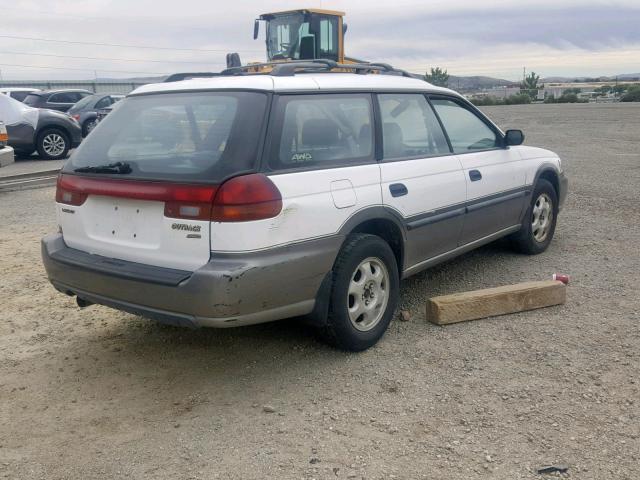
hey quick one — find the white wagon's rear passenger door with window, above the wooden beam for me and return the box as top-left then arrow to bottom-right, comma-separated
377,93 -> 466,269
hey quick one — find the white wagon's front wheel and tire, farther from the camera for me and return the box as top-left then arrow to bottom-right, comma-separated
511,178 -> 558,255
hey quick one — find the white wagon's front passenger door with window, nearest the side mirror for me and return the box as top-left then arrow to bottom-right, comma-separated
431,96 -> 525,244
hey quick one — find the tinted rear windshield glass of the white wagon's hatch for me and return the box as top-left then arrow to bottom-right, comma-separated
64,92 -> 267,182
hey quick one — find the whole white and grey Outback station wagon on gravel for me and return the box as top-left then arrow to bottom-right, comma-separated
42,62 -> 567,350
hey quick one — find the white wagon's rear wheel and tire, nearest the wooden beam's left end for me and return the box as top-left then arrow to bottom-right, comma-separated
323,234 -> 400,352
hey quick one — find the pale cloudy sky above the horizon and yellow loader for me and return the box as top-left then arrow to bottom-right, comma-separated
0,0 -> 640,80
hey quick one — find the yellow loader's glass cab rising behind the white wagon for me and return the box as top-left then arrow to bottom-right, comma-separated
253,10 -> 346,63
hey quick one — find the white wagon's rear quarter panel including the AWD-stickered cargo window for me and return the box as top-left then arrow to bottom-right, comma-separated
233,93 -> 381,250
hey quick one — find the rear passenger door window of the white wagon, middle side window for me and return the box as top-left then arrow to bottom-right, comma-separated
378,93 -> 450,159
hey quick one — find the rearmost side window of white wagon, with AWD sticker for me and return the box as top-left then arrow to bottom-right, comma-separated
269,94 -> 373,169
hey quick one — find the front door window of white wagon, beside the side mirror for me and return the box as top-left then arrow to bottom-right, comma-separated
431,98 -> 499,153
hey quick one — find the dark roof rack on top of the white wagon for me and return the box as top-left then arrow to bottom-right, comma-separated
165,58 -> 422,82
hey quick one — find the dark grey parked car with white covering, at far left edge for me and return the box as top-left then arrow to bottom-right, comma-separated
0,95 -> 82,160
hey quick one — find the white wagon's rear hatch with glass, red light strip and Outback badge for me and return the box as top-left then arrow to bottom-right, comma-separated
56,91 -> 267,271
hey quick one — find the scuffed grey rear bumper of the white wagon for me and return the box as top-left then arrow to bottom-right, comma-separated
42,234 -> 343,327
